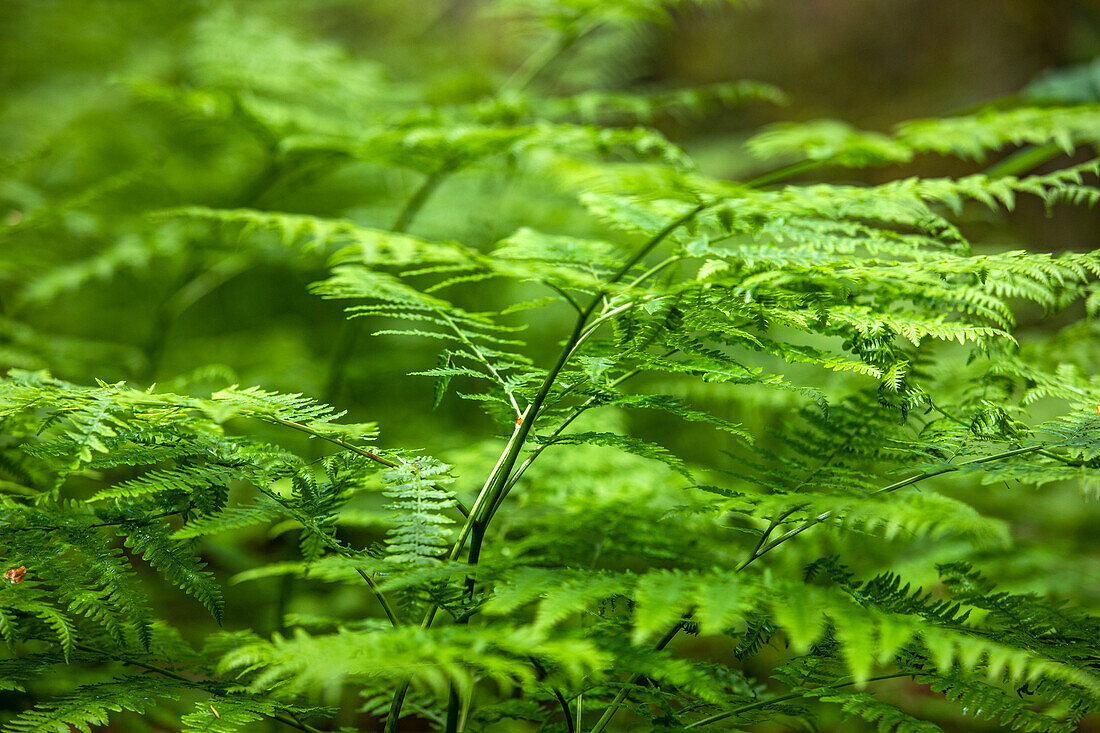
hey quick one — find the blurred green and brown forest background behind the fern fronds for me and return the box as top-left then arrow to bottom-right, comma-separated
0,0 -> 1100,731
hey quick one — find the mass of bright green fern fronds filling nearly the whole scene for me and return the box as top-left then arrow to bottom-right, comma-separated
0,0 -> 1100,733
